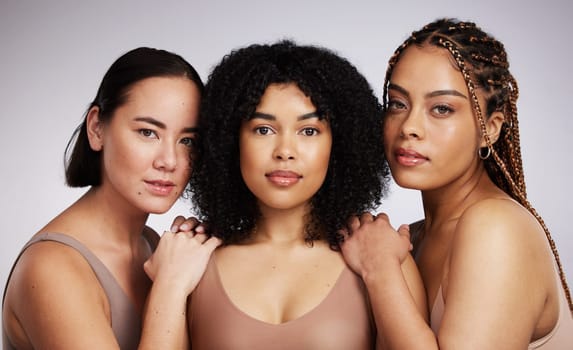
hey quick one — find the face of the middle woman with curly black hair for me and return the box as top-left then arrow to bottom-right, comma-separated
239,84 -> 332,210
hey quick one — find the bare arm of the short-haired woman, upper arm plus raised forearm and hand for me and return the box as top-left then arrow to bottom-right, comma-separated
4,228 -> 219,349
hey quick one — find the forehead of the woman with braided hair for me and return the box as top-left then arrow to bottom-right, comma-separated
390,45 -> 467,92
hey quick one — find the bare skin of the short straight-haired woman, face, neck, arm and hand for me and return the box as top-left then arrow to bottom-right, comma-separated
3,77 -> 220,349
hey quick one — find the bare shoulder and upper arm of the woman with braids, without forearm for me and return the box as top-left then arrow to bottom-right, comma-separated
439,198 -> 556,348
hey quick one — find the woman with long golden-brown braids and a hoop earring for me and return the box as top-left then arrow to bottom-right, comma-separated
342,19 -> 573,349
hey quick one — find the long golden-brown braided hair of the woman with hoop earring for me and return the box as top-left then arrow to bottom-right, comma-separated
383,19 -> 573,313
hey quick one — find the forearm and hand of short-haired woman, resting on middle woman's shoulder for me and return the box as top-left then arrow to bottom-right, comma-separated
140,232 -> 221,349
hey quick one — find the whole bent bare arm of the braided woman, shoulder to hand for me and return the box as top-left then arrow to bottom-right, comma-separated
343,200 -> 555,349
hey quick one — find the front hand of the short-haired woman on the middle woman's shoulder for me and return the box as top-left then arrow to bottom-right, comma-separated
143,232 -> 222,295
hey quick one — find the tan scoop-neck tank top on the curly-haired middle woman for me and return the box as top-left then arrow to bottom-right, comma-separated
189,259 -> 376,350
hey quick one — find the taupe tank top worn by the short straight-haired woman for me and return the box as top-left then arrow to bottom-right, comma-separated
2,233 -> 153,350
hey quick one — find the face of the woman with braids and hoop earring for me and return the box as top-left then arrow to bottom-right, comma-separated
384,46 -> 483,190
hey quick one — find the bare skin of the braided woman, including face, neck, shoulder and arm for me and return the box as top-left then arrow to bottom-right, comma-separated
342,46 -> 560,349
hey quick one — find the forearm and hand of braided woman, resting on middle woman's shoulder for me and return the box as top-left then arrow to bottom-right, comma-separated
342,214 -> 437,349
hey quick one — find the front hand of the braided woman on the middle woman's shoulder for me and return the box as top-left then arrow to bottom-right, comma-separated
341,213 -> 412,277
